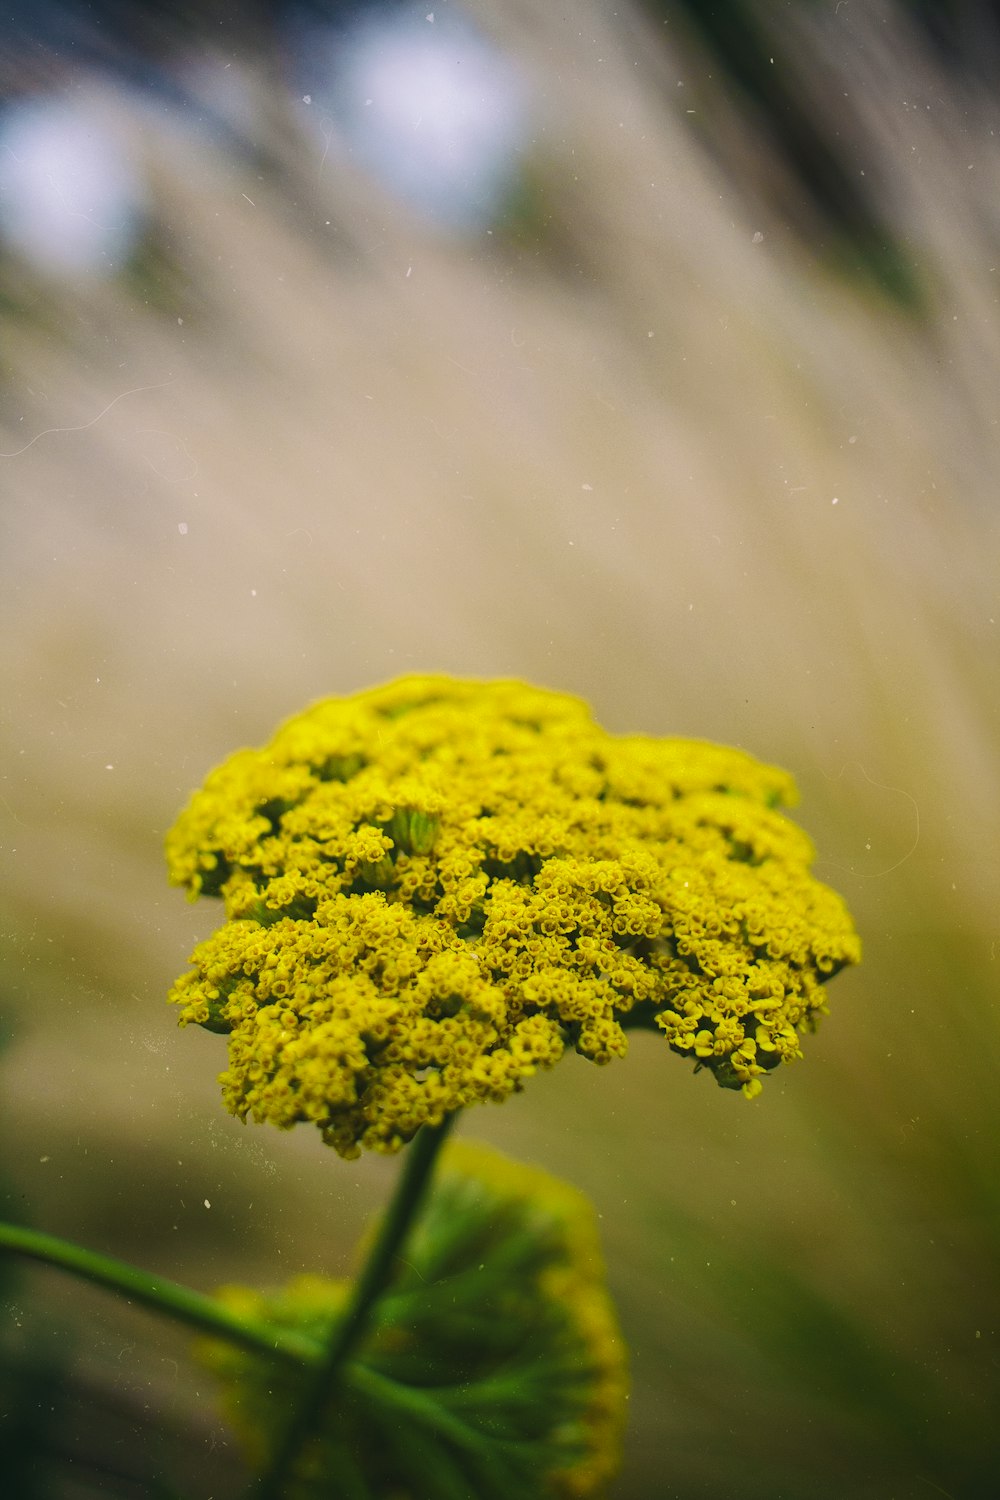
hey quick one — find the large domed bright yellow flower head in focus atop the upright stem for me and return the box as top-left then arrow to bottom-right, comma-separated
166,677 -> 859,1157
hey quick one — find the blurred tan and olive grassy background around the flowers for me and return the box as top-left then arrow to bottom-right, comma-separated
0,0 -> 1000,1500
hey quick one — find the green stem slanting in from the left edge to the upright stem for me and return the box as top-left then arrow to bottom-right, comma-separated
0,1224 -> 324,1367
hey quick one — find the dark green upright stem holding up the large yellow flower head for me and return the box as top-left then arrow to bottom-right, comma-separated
253,1115 -> 454,1500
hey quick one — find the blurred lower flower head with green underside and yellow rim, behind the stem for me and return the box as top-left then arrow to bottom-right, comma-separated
199,1142 -> 628,1500
